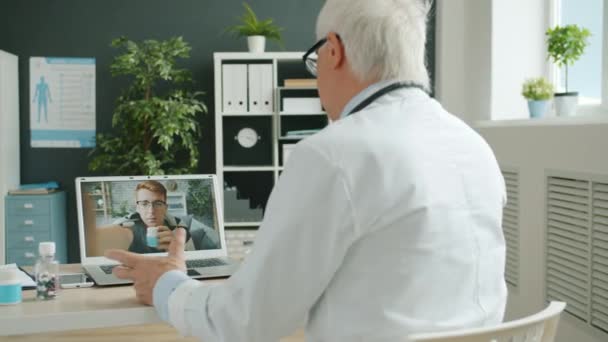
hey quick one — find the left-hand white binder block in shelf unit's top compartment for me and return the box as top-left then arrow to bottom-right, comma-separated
222,64 -> 247,114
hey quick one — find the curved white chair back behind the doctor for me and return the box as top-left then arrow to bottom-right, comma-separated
408,302 -> 566,342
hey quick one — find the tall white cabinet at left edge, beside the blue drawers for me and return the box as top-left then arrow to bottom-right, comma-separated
0,50 -> 20,265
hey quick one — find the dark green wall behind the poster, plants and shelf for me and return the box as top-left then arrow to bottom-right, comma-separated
0,0 -> 434,262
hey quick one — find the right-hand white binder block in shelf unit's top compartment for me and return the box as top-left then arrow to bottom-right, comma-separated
248,64 -> 274,114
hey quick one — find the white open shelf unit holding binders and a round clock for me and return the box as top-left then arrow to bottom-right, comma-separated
213,52 -> 326,229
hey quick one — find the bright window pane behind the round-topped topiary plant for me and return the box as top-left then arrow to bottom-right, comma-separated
552,0 -> 608,114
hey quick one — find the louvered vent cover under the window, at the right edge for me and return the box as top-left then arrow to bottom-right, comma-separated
545,171 -> 608,333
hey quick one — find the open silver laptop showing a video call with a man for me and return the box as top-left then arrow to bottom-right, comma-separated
76,175 -> 238,286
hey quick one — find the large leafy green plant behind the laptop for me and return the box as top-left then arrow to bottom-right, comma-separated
89,37 -> 207,175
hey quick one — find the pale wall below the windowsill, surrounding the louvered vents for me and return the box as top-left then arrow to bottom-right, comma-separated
476,121 -> 608,342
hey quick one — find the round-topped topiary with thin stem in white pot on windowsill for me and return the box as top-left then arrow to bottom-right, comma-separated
546,25 -> 591,116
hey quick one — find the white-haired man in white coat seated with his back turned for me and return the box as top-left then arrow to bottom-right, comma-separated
108,0 -> 507,342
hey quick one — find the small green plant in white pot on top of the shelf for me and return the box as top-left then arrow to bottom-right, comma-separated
226,2 -> 283,53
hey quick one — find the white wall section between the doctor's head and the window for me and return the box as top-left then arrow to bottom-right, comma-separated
436,0 -> 549,123
